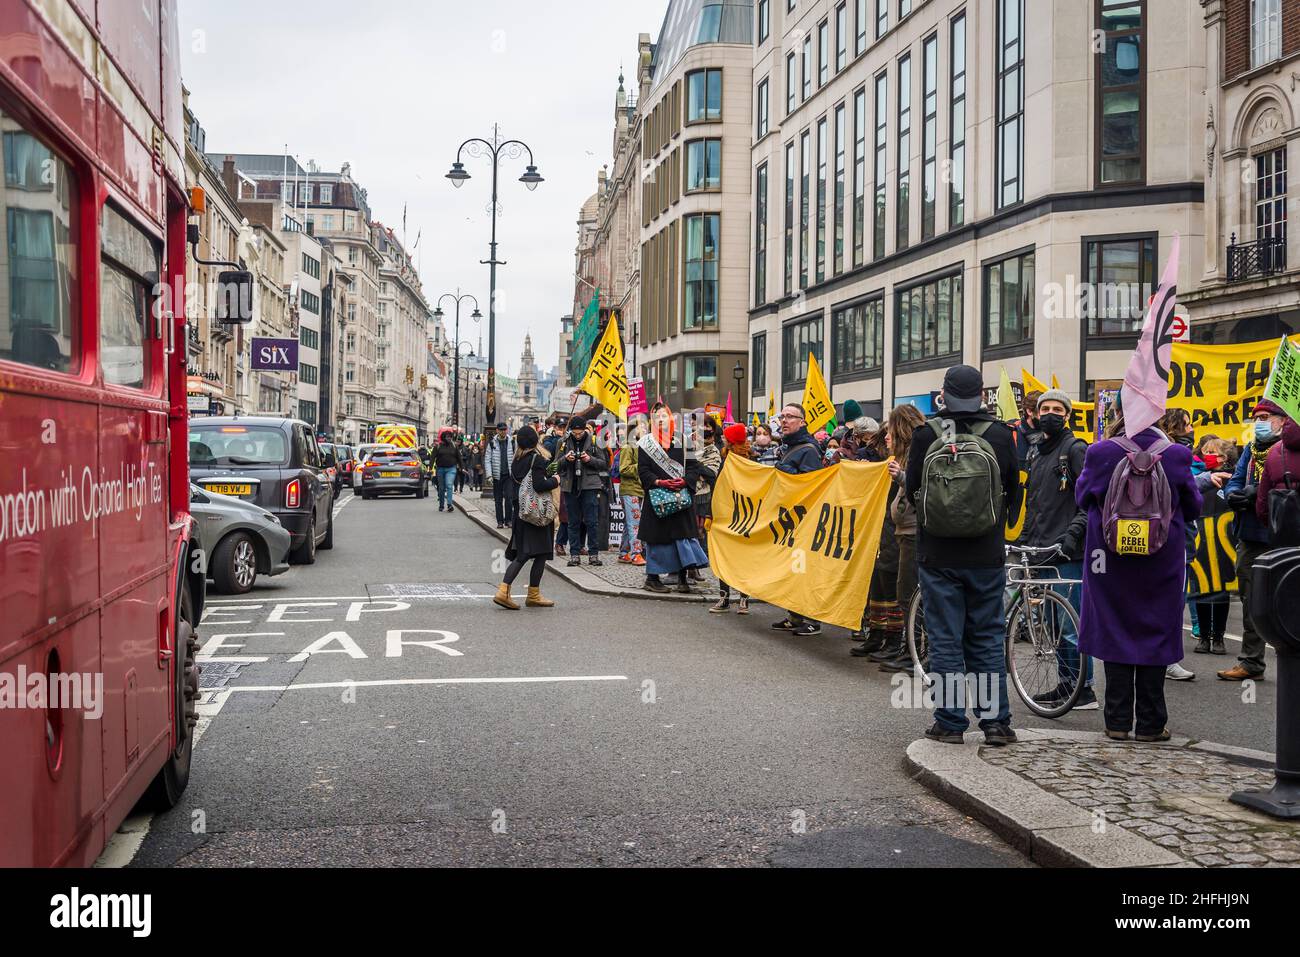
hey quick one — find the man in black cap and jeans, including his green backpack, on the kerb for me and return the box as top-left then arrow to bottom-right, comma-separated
905,365 -> 1021,746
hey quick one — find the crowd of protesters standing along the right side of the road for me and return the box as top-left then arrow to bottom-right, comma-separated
483,365 -> 1300,745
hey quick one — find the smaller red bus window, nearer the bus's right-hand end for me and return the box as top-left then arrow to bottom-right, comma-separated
99,205 -> 160,389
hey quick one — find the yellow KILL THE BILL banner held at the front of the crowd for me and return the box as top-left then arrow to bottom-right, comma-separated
709,455 -> 889,629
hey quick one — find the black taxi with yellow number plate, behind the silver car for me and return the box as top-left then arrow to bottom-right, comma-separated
190,416 -> 334,564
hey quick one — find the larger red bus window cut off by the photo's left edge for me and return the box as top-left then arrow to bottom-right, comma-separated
0,107 -> 81,372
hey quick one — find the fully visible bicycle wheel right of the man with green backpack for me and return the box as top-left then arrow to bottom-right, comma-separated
1006,589 -> 1083,718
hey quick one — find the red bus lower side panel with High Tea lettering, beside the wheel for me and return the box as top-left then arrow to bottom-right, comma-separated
99,404 -> 172,794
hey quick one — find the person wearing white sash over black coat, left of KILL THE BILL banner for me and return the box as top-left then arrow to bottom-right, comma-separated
637,406 -> 709,594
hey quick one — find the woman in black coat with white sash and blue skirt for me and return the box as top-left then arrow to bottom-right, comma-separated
637,408 -> 709,594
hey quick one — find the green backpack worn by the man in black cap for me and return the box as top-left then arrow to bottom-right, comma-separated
917,419 -> 1004,538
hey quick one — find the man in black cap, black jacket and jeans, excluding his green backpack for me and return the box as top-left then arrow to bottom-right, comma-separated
905,365 -> 1021,745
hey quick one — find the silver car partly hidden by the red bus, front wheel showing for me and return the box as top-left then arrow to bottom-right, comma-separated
190,482 -> 291,594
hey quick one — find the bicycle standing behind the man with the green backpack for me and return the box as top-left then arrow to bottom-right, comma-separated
905,545 -> 1086,718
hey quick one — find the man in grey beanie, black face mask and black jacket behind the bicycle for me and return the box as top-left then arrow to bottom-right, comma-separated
1019,389 -> 1100,711
